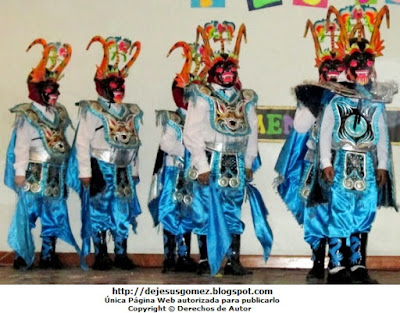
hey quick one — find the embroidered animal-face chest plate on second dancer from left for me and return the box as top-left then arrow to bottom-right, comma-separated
89,101 -> 142,149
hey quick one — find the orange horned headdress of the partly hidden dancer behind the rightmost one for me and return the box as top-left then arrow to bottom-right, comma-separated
304,20 -> 345,67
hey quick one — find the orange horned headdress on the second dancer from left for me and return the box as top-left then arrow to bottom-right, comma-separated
86,36 -> 141,80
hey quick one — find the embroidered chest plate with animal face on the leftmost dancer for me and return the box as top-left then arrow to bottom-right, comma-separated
11,103 -> 71,159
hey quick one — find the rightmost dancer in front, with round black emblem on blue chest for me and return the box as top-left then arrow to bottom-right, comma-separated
319,6 -> 397,284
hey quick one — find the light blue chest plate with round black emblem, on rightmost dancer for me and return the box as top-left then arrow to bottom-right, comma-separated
335,100 -> 378,149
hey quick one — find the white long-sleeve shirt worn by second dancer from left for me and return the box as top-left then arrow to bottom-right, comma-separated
75,98 -> 139,178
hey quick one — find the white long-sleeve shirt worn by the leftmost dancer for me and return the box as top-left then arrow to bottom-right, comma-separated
14,102 -> 56,176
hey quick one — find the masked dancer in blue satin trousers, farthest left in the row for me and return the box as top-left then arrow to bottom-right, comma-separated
4,38 -> 80,270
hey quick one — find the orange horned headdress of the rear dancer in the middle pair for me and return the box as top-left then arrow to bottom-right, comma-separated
167,41 -> 207,88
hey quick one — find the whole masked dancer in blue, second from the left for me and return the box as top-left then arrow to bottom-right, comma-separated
69,36 -> 143,270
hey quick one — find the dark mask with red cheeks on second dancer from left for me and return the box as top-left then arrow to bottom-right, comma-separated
94,76 -> 125,103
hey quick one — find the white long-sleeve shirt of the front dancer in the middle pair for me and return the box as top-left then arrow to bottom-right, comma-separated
183,84 -> 258,174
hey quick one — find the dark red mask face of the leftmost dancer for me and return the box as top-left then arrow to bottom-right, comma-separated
28,80 -> 60,106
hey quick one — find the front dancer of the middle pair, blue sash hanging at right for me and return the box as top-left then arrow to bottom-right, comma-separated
183,21 -> 272,275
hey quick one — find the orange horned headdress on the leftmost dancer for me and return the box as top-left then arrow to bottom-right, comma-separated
26,38 -> 72,83
